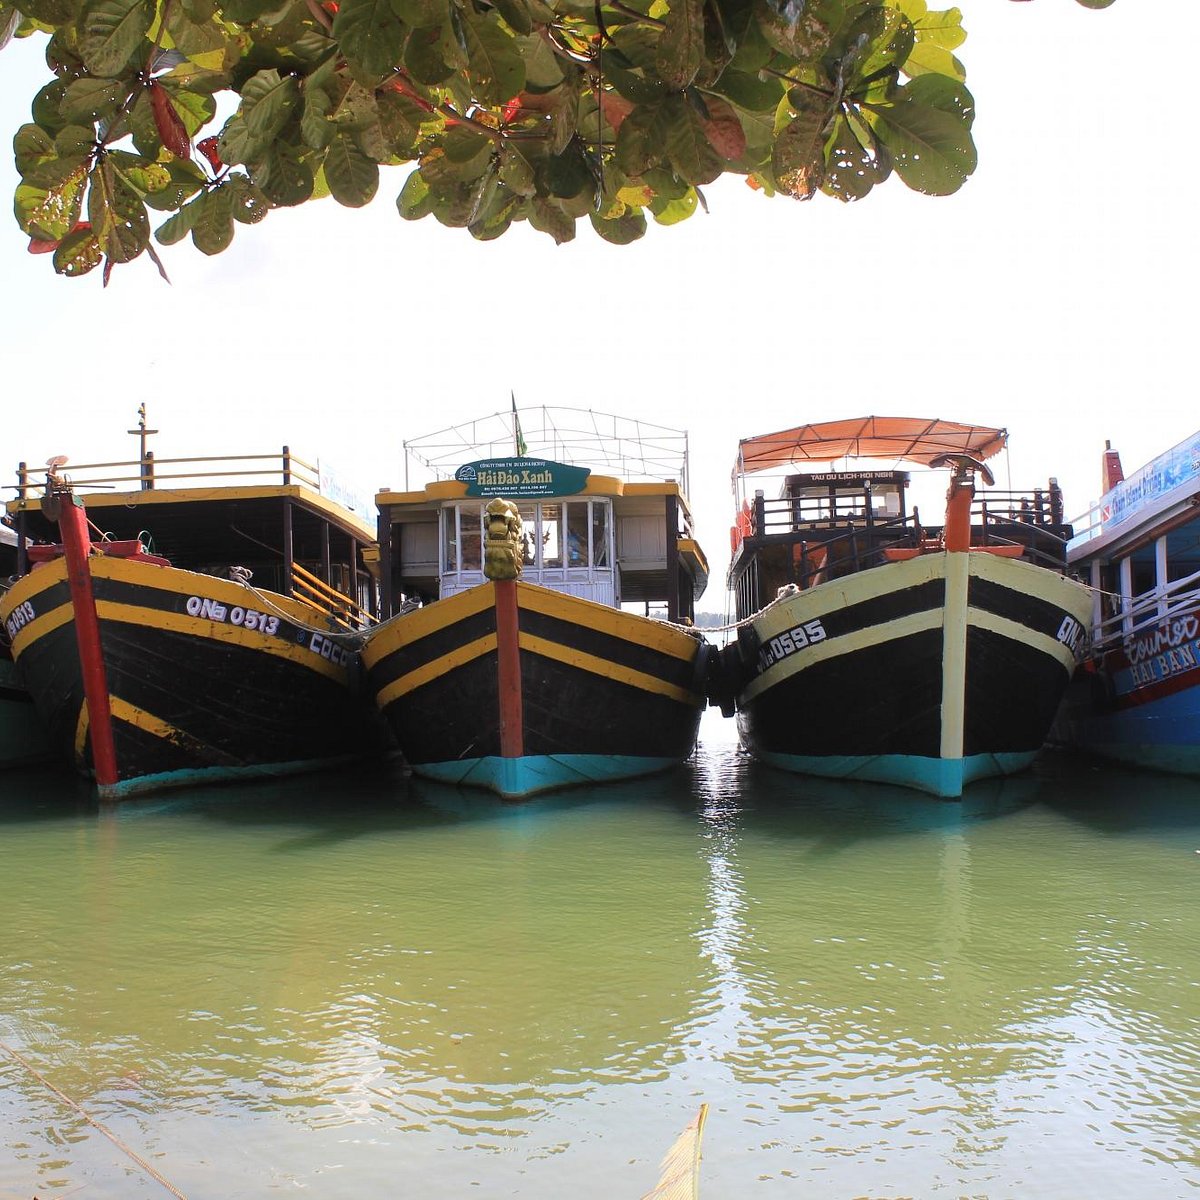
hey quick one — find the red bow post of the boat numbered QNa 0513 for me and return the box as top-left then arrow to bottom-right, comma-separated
52,488 -> 118,788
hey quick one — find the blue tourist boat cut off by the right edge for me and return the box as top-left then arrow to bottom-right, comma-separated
1051,433 -> 1200,775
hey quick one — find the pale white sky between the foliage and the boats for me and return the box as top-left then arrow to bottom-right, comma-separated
0,0 -> 1200,600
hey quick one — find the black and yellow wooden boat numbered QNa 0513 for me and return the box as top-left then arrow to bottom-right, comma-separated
0,432 -> 374,799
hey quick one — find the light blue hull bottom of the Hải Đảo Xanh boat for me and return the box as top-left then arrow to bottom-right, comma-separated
409,754 -> 679,800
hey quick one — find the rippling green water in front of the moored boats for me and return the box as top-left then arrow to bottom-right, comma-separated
0,714 -> 1200,1200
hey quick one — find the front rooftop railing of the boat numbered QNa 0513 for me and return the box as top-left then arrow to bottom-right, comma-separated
16,446 -> 322,500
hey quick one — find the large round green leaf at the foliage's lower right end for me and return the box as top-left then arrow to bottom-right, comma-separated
868,74 -> 977,196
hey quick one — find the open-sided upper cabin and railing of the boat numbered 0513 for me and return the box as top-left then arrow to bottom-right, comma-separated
6,446 -> 378,629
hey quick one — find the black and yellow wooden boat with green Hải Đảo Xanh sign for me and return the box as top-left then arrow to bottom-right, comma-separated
362,408 -> 709,798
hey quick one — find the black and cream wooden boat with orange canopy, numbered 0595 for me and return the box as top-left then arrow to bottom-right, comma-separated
716,416 -> 1091,797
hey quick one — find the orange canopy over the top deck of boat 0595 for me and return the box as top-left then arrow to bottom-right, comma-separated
734,416 -> 1008,473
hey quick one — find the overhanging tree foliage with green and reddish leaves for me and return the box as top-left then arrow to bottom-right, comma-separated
0,0 -> 1112,280
